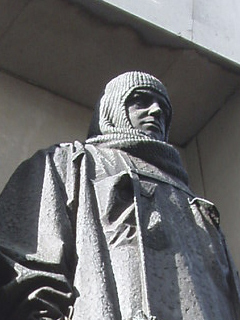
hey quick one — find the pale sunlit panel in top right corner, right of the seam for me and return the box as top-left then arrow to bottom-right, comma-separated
193,0 -> 240,62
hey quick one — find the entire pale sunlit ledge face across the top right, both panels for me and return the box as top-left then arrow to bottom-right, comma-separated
103,0 -> 240,63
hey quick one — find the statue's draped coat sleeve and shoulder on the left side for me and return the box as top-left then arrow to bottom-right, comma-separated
0,144 -> 84,320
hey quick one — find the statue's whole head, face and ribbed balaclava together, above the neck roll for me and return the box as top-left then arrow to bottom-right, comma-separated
88,71 -> 172,141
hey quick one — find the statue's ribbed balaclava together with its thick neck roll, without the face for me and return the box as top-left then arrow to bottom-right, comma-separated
86,71 -> 187,183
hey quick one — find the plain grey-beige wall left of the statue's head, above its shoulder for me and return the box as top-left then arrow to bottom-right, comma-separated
0,73 -> 91,190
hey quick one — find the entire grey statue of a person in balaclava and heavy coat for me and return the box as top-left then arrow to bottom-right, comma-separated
0,71 -> 240,320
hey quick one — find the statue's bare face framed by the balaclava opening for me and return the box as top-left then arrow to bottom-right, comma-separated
125,89 -> 170,141
